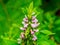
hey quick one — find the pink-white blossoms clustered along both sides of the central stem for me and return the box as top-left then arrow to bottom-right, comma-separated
18,16 -> 40,43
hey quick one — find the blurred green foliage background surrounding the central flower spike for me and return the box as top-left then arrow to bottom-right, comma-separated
0,0 -> 60,45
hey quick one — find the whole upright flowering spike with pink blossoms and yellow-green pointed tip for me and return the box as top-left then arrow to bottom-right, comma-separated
18,3 -> 40,45
